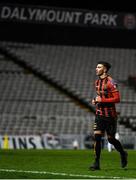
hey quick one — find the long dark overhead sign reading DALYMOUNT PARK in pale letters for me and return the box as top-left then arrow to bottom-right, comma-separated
0,4 -> 136,29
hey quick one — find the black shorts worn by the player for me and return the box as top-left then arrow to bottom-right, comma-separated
93,116 -> 117,136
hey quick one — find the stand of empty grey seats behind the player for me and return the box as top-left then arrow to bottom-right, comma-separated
0,42 -> 136,137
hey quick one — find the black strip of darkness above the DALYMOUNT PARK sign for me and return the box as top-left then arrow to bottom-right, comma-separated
0,0 -> 136,13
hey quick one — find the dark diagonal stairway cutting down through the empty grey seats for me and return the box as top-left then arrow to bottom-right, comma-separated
0,42 -> 95,113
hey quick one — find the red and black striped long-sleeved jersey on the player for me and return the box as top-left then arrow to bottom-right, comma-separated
95,76 -> 120,117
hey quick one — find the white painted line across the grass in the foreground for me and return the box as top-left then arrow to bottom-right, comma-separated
0,169 -> 132,179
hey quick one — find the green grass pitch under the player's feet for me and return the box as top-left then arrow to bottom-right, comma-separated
0,150 -> 136,179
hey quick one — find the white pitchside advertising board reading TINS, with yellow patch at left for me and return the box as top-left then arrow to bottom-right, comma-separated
0,134 -> 61,149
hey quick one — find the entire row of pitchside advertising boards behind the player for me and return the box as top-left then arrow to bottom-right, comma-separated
0,133 -> 136,149
